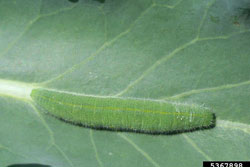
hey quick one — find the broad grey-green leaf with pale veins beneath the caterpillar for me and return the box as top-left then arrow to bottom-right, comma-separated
0,0 -> 250,167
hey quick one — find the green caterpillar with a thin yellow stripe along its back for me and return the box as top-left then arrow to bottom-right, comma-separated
31,88 -> 215,134
